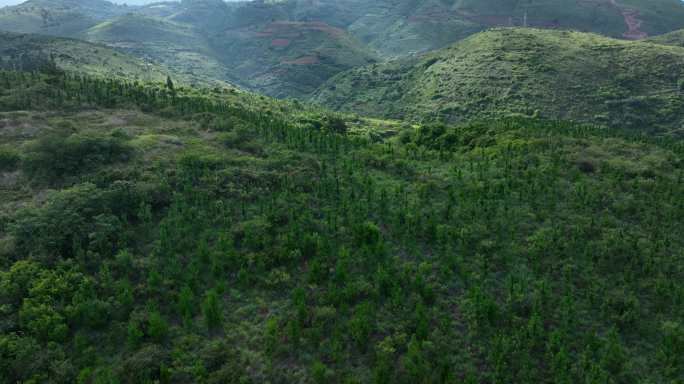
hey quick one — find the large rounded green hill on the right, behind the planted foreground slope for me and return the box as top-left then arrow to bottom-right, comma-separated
312,28 -> 684,132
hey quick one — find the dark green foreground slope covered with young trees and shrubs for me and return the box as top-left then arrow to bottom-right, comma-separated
0,67 -> 684,383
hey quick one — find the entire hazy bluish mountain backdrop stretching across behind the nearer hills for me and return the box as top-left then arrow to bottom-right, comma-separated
0,0 -> 684,98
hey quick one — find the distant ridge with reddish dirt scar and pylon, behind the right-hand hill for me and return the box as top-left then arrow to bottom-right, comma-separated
349,0 -> 684,56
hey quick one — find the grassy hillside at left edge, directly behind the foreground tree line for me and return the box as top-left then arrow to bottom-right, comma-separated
0,32 -> 184,83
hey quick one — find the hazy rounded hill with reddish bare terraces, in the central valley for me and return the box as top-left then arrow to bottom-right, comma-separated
211,21 -> 375,97
